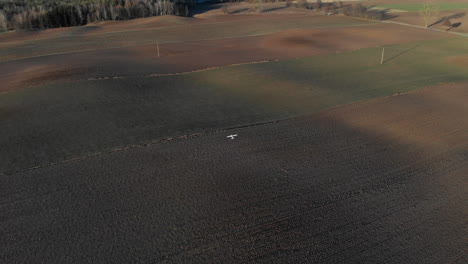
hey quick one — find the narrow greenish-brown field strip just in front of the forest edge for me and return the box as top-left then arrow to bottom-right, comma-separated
0,15 -> 373,61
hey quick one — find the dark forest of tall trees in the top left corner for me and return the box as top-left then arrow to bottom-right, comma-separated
0,0 -> 193,30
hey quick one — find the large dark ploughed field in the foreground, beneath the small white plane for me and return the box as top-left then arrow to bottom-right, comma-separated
0,84 -> 468,263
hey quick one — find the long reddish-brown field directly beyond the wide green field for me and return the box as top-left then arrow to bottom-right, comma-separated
0,24 -> 447,92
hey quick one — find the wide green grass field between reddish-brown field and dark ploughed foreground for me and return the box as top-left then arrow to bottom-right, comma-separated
0,37 -> 468,172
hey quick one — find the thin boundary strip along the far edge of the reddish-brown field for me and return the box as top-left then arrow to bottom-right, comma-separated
0,23 -> 378,63
